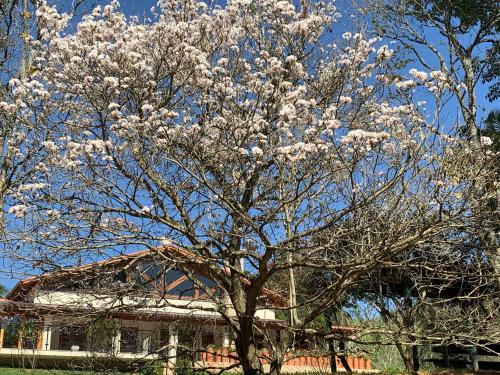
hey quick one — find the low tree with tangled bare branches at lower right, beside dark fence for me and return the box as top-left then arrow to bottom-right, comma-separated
299,204 -> 500,372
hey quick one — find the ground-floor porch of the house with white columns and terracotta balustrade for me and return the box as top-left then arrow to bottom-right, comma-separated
0,316 -> 371,373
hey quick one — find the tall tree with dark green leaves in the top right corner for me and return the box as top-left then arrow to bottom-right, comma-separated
365,0 -> 500,140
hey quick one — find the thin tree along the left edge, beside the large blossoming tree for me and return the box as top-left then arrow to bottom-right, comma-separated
0,0 -> 102,235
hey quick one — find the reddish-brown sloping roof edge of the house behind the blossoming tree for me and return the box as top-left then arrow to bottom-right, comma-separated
6,245 -> 287,307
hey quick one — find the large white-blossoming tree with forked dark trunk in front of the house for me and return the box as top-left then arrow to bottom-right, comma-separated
7,0 -> 496,374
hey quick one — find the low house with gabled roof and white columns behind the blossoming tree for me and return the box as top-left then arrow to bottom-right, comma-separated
0,245 -> 370,372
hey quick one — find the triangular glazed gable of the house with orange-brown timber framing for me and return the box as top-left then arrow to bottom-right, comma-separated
6,245 -> 287,307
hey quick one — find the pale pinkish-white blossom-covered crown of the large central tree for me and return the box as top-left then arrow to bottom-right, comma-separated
6,0 -> 476,232
